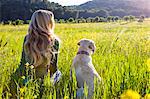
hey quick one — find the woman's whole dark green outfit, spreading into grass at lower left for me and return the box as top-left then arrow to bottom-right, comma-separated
9,37 -> 59,96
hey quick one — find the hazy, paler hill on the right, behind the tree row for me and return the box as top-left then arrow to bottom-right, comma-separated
77,0 -> 150,16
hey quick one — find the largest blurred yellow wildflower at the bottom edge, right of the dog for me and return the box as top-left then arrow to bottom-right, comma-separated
120,90 -> 141,99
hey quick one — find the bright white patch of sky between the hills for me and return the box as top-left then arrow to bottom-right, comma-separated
49,0 -> 92,6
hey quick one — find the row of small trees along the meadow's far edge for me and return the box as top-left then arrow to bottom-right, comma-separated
1,15 -> 145,25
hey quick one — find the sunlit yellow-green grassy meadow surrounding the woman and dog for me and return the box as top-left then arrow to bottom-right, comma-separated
0,21 -> 150,99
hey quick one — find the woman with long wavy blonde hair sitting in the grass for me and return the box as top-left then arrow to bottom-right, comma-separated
7,10 -> 61,98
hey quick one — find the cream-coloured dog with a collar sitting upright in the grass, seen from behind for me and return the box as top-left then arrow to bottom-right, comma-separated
70,39 -> 101,99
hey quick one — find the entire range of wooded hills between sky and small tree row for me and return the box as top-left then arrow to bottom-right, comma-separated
0,0 -> 150,22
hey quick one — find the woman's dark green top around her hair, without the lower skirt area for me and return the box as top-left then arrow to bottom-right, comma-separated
18,37 -> 59,78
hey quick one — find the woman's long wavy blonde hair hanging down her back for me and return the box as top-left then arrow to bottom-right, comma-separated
24,10 -> 55,67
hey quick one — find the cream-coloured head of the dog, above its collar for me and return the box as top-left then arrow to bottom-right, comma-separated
78,39 -> 96,53
